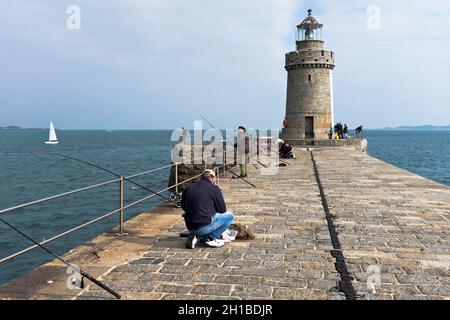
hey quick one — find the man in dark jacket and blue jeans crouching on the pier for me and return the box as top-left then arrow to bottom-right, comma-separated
181,170 -> 234,249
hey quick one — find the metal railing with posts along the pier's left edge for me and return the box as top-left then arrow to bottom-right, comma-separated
0,150 -> 229,264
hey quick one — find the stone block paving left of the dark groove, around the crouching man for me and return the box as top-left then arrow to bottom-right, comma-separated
78,151 -> 345,300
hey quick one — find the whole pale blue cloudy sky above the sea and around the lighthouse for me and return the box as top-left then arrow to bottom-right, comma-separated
0,0 -> 450,129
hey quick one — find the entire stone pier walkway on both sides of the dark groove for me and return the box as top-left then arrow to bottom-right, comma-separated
0,148 -> 450,300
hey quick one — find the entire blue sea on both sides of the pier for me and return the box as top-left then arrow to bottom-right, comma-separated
0,129 -> 450,284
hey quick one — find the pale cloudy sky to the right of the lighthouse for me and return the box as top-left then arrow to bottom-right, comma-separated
319,0 -> 450,127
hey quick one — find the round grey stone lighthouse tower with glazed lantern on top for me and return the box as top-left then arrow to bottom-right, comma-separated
281,10 -> 334,142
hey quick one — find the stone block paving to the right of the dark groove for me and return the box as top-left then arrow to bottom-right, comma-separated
314,149 -> 450,299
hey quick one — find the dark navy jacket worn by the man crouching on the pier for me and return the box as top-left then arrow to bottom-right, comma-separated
181,178 -> 227,230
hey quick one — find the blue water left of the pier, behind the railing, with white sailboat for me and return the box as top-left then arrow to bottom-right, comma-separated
0,130 -> 172,283
